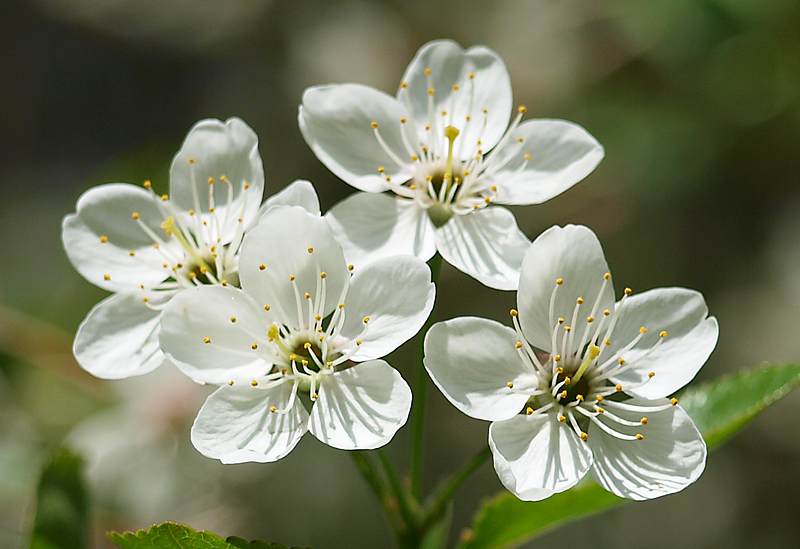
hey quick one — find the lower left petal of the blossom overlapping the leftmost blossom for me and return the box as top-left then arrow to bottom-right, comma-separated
192,376 -> 308,463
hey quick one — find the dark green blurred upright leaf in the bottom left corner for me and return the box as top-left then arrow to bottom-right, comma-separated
31,448 -> 89,549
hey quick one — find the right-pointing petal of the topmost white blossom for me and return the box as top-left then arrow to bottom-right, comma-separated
486,120 -> 605,204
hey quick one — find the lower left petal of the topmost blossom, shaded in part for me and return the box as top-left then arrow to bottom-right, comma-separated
325,193 -> 436,265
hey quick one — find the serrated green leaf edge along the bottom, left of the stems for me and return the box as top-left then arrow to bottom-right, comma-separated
108,522 -> 308,549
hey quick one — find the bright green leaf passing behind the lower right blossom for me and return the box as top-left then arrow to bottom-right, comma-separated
459,364 -> 800,549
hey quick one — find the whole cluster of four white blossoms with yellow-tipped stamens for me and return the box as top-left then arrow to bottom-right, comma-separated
63,41 -> 718,500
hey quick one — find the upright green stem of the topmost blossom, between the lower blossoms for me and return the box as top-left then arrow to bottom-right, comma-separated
408,253 -> 442,499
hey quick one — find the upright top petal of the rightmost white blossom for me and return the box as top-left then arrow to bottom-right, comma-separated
517,225 -> 614,352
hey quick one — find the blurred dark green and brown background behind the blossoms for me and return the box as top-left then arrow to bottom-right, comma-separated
0,0 -> 800,549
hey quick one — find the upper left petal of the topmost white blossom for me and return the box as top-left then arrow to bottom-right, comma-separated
298,84 -> 414,192
